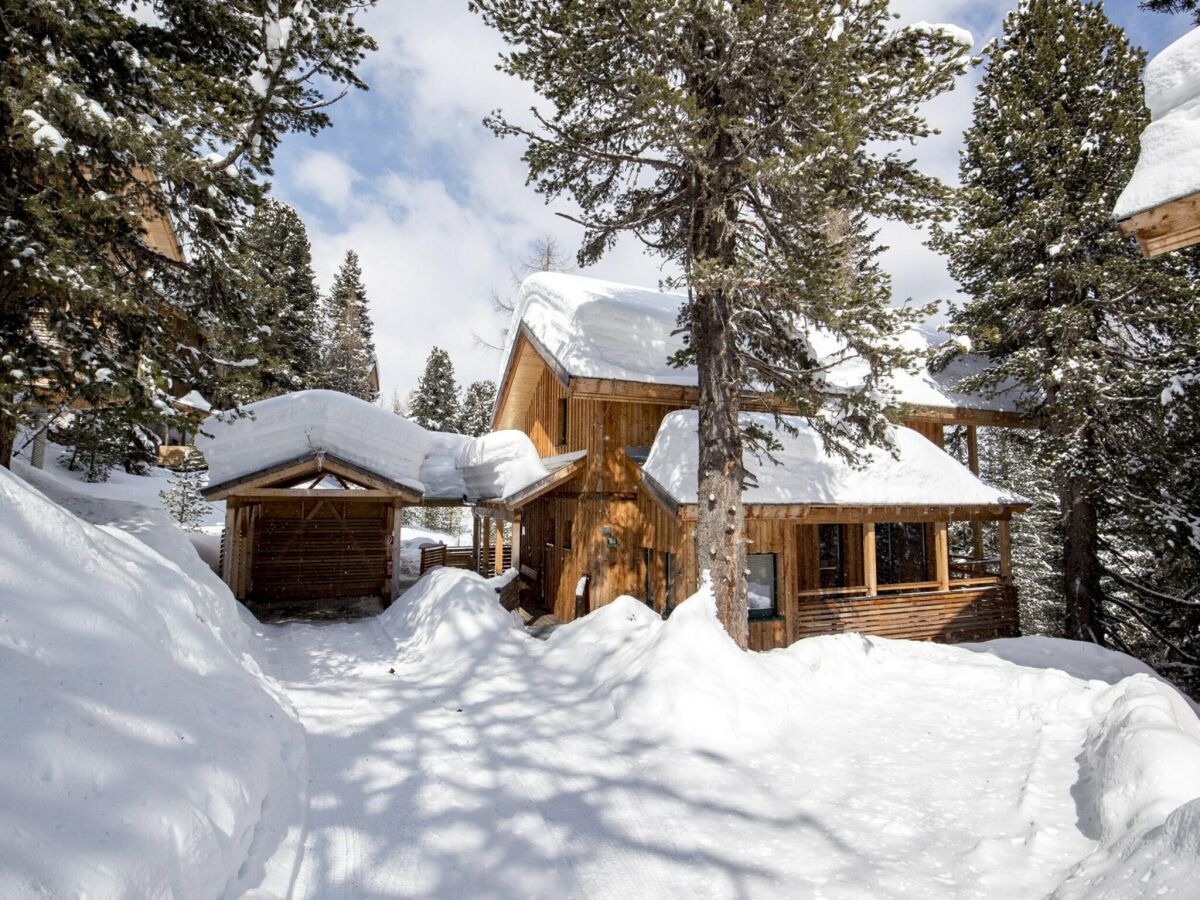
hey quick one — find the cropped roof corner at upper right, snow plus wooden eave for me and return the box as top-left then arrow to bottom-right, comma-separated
1114,28 -> 1200,257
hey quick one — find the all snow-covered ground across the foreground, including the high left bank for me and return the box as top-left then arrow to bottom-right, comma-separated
0,460 -> 1200,900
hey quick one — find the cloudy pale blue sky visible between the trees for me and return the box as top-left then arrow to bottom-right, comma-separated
272,0 -> 1190,401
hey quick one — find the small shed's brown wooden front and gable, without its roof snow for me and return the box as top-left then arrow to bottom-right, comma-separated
204,451 -> 421,602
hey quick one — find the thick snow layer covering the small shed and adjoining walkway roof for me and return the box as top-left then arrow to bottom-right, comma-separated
196,390 -> 550,500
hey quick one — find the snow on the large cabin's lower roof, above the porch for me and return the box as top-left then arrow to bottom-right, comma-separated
643,409 -> 1027,506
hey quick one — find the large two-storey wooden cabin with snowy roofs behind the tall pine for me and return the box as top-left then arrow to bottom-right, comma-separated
476,274 -> 1027,649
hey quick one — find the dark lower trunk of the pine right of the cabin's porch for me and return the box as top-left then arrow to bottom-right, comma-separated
1058,478 -> 1104,644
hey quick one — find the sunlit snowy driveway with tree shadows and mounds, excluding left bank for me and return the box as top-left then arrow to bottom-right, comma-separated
264,569 -> 1200,899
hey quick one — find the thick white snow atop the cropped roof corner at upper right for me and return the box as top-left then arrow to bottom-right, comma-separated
1112,28 -> 1200,220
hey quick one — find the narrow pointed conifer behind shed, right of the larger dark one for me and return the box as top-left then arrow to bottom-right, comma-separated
320,250 -> 379,403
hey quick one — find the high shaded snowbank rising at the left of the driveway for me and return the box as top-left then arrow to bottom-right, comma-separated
0,469 -> 304,898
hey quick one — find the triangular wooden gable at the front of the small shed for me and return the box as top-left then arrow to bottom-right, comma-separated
200,452 -> 421,504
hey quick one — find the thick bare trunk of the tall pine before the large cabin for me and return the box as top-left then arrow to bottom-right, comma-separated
691,290 -> 750,648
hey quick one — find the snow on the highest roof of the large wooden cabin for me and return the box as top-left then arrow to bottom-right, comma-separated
497,272 -> 1020,413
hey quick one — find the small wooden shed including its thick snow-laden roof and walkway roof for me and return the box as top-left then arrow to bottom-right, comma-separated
197,390 -> 572,604
